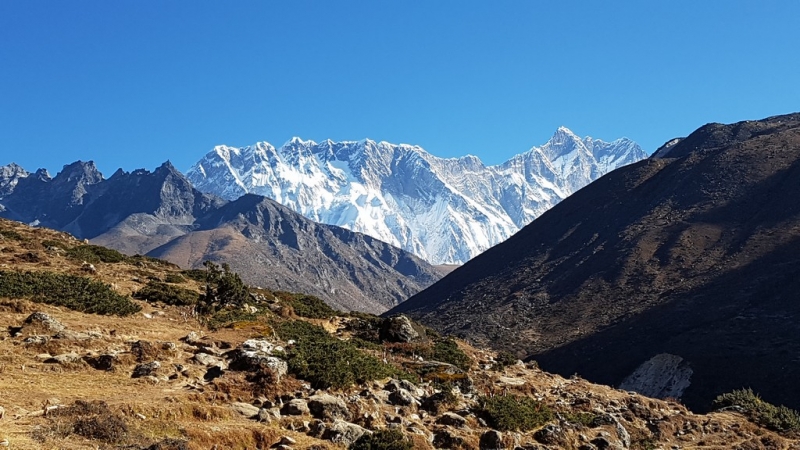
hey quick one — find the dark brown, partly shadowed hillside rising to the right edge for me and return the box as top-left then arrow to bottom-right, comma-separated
387,114 -> 800,409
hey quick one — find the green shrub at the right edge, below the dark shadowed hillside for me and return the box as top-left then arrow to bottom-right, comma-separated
713,388 -> 800,433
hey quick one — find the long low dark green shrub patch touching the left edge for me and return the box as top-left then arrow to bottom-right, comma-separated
0,271 -> 142,316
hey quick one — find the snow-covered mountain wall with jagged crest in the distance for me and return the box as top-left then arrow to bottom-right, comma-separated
187,127 -> 646,264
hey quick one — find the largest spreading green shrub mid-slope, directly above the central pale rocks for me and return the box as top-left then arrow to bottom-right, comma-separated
275,320 -> 401,389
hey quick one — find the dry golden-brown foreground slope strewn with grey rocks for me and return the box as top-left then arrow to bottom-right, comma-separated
0,217 -> 800,450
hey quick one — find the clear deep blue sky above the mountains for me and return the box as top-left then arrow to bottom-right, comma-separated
0,0 -> 800,176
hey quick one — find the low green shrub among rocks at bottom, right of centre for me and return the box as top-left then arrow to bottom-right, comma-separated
478,395 -> 553,431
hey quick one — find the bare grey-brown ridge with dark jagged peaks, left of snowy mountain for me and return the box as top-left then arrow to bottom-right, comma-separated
0,161 -> 441,313
